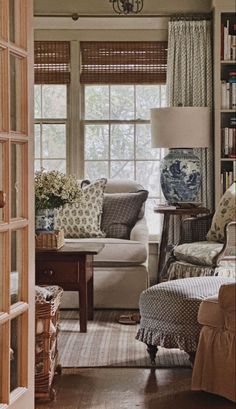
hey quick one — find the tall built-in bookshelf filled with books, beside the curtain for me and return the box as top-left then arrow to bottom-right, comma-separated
213,0 -> 236,205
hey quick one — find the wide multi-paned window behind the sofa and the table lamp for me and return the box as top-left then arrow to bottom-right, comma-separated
84,85 -> 166,234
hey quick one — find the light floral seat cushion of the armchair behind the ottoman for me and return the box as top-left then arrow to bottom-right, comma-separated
174,241 -> 223,266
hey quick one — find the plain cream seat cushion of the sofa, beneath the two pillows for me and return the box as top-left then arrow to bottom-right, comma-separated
66,238 -> 147,267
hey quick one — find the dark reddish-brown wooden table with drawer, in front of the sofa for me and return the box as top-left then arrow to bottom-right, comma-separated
36,243 -> 104,332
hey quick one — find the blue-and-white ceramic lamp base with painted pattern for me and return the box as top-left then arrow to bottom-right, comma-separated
161,149 -> 201,204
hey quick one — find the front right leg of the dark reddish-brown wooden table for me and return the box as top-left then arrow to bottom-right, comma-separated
79,262 -> 88,332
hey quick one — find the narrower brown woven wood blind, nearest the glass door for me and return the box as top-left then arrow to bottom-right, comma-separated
34,41 -> 70,84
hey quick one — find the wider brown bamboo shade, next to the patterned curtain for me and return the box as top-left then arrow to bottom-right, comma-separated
80,41 -> 167,84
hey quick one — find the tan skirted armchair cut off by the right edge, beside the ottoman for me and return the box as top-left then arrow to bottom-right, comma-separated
192,284 -> 236,402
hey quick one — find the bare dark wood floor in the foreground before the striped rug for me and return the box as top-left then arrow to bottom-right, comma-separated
36,368 -> 235,409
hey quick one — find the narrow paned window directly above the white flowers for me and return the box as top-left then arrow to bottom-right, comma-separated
34,85 -> 67,173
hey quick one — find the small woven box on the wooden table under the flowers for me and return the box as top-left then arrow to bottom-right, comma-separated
35,230 -> 64,250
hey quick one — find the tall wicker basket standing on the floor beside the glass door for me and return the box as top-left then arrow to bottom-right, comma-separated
35,287 -> 63,399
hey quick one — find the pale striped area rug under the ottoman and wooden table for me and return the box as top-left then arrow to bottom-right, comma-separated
58,311 -> 190,366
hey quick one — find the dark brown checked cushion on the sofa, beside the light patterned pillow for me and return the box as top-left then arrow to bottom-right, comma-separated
102,190 -> 148,239
